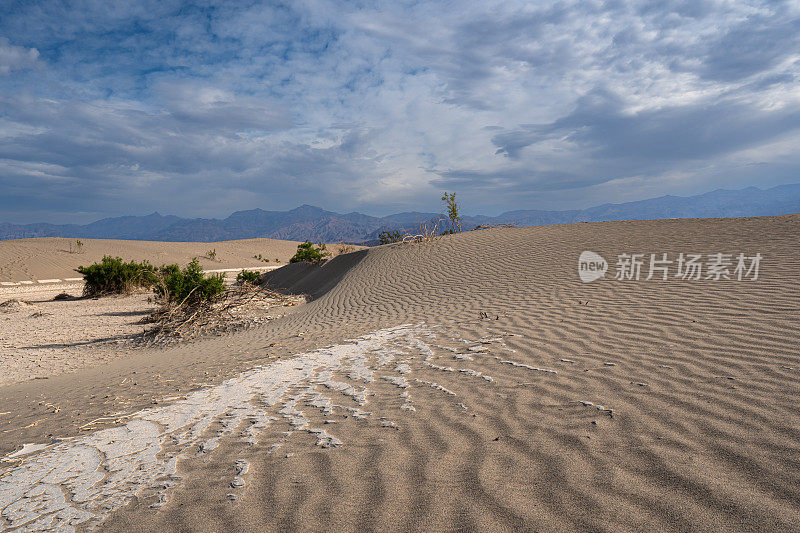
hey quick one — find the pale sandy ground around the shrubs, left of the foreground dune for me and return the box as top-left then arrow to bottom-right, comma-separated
0,238 -> 318,386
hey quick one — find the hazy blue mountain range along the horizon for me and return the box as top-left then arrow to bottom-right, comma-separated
0,184 -> 800,243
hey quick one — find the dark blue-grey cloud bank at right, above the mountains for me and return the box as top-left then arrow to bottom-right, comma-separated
492,91 -> 800,163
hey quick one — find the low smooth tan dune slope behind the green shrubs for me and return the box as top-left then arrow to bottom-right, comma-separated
0,237 -> 304,282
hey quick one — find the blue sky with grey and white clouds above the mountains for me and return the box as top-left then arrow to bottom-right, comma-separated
0,0 -> 800,223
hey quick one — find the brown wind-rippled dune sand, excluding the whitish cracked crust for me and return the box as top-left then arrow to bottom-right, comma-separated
0,215 -> 800,532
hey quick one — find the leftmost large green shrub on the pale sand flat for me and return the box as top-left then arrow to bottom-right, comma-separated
75,255 -> 156,296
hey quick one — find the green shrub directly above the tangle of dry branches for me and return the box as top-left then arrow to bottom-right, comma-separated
154,258 -> 225,305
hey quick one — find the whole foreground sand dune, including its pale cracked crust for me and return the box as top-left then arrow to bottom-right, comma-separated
0,215 -> 800,531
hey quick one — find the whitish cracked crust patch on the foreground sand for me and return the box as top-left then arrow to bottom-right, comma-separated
0,325 -> 478,531
